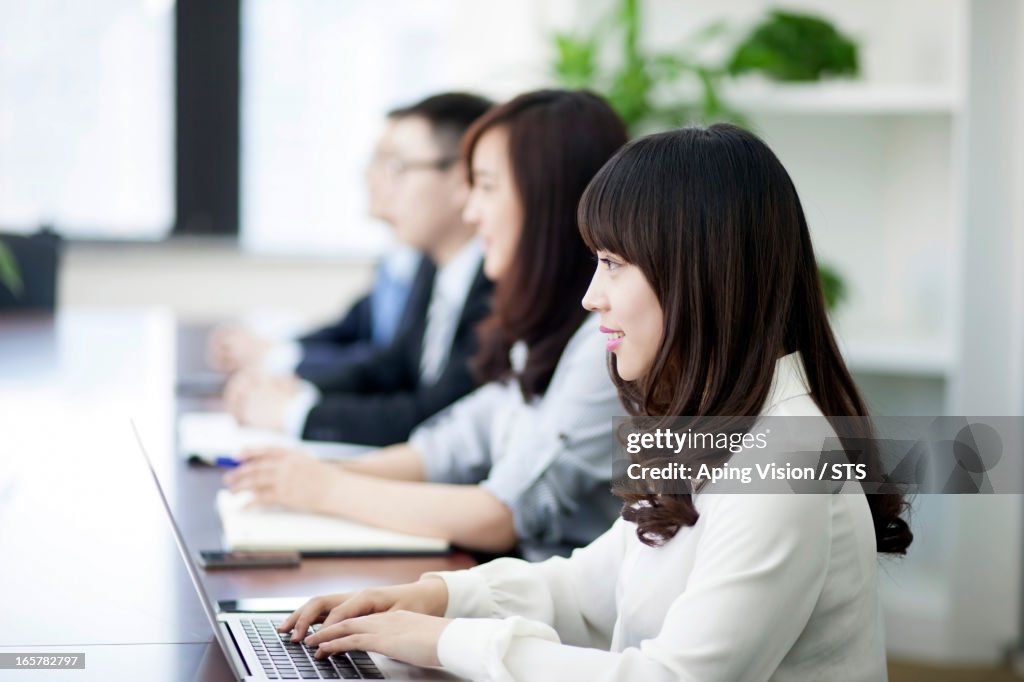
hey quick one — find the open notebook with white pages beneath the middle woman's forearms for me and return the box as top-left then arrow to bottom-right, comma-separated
217,491 -> 450,556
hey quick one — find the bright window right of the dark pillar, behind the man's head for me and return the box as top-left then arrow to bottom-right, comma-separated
241,0 -> 546,256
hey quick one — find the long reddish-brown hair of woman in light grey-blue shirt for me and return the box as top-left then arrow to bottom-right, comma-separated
462,90 -> 627,400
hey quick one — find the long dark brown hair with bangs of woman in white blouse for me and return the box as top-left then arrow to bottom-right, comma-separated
579,124 -> 913,554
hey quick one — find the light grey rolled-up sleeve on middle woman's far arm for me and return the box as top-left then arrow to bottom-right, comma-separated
409,382 -> 507,483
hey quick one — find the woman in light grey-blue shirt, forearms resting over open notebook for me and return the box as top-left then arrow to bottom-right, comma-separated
225,90 -> 626,559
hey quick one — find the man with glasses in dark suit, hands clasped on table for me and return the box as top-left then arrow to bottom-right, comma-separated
225,94 -> 492,445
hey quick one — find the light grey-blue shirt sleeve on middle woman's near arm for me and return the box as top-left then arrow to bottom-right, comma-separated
481,316 -> 625,546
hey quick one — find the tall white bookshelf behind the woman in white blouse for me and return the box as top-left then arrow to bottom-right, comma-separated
630,0 -> 1024,663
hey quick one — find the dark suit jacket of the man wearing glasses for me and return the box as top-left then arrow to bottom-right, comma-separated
302,258 -> 494,445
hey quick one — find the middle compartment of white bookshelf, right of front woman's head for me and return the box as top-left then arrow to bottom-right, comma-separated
757,104 -> 963,399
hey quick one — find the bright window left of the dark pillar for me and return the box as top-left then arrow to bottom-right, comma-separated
0,0 -> 174,239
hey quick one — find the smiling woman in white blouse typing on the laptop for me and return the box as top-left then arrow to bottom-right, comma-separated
282,124 -> 911,682
